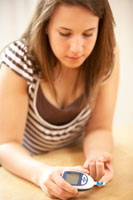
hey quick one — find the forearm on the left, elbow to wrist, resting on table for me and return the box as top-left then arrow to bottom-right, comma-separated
0,142 -> 47,185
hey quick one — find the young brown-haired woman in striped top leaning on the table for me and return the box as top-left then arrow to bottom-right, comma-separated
0,0 -> 119,199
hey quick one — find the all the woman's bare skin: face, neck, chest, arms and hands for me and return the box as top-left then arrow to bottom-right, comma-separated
0,2 -> 119,200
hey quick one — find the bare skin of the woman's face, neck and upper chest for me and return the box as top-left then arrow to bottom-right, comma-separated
41,5 -> 99,108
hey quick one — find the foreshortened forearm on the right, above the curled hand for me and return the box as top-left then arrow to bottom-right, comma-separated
83,130 -> 113,159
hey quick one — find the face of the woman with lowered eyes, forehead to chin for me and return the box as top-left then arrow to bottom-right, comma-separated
47,4 -> 99,69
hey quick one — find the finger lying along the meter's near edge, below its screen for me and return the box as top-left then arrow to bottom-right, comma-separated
52,173 -> 78,196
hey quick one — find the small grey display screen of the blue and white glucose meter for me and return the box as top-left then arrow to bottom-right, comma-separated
66,173 -> 80,184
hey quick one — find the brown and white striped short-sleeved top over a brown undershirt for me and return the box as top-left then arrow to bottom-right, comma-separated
0,40 -> 91,155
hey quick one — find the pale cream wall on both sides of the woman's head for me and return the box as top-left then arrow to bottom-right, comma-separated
0,0 -> 133,127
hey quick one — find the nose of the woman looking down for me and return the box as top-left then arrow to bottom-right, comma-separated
70,38 -> 83,56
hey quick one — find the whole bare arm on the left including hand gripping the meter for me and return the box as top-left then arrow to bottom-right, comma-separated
0,65 -> 86,199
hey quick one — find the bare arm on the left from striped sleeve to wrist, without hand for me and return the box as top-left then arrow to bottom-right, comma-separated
0,66 -> 46,182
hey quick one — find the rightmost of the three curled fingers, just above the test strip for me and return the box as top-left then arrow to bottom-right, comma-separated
96,161 -> 105,181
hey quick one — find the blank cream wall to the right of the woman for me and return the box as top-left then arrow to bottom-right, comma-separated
109,0 -> 133,127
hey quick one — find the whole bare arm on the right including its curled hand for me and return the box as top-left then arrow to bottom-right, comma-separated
84,48 -> 119,182
